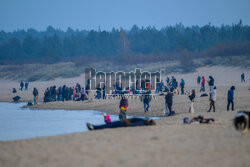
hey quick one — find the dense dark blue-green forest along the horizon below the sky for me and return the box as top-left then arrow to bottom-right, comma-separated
0,21 -> 250,65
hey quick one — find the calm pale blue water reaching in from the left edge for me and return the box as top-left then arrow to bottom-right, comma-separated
0,102 -> 156,141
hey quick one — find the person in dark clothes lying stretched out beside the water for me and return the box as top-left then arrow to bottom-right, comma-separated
87,118 -> 156,130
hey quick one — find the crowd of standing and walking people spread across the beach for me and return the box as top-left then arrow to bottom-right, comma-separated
16,73 -> 248,120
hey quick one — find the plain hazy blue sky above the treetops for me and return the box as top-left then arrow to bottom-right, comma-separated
0,0 -> 250,31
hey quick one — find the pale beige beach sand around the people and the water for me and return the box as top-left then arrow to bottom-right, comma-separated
0,67 -> 250,167
